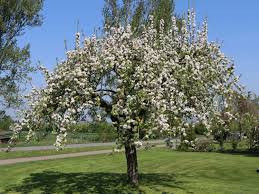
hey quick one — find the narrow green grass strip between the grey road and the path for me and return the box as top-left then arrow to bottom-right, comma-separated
0,146 -> 113,160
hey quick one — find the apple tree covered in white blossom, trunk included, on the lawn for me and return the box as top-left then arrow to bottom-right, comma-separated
8,12 -> 240,184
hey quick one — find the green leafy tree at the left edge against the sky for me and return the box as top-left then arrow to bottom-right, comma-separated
0,0 -> 43,106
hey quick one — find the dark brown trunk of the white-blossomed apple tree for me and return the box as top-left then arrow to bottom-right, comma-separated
125,145 -> 138,185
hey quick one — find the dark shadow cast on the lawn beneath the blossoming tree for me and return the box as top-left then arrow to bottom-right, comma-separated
5,171 -> 184,194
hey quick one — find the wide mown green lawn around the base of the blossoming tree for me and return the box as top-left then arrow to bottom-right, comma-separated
0,148 -> 259,194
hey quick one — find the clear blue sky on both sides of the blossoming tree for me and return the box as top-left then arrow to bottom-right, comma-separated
19,0 -> 259,94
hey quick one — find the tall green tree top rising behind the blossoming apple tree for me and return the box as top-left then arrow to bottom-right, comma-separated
103,0 -> 174,33
